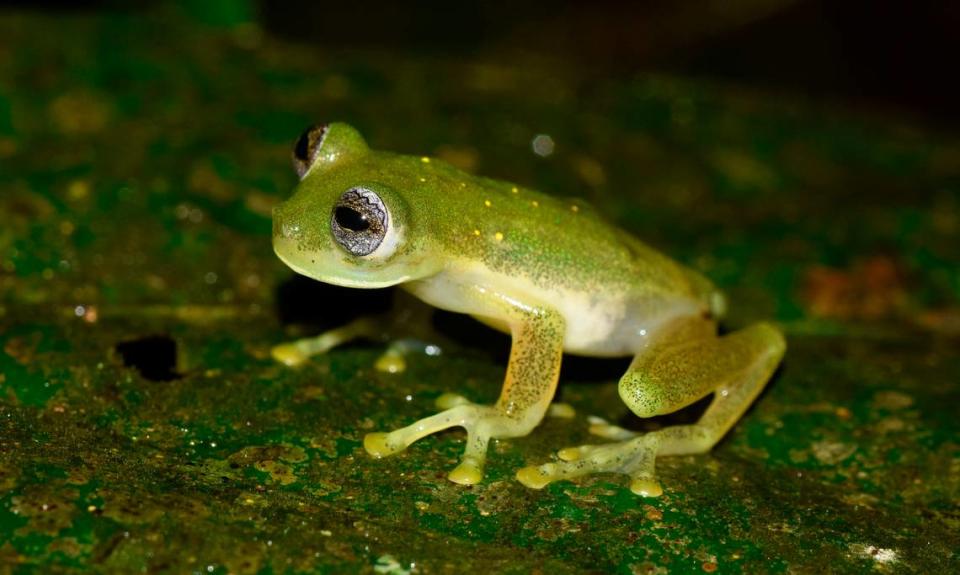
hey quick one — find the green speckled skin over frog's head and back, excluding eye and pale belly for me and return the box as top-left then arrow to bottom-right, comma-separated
274,123 -> 713,305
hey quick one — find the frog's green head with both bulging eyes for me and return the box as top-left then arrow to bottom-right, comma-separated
273,123 -> 439,288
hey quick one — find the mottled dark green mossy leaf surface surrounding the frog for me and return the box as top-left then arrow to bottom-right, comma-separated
0,3 -> 960,573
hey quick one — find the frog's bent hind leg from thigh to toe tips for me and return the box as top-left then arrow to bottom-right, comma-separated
517,320 -> 786,496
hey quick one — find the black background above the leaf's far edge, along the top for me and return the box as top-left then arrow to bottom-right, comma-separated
7,0 -> 960,128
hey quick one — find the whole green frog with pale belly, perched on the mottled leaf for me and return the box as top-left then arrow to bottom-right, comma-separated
273,123 -> 786,496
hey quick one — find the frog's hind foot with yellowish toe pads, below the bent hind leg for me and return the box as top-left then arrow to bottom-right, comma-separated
517,430 -> 663,497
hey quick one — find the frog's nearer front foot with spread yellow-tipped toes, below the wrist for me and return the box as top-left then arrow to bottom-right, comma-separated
363,400 -> 529,485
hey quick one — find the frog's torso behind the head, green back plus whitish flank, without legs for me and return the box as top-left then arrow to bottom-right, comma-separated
379,156 -> 715,356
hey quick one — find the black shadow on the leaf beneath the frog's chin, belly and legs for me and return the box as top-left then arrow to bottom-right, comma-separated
276,275 -> 782,431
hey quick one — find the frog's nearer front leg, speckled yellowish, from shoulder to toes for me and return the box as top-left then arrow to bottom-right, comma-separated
363,288 -> 564,485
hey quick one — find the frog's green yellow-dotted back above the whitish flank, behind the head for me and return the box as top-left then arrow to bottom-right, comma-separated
445,169 -> 716,308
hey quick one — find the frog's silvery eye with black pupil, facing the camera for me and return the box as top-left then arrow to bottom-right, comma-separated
330,188 -> 390,256
